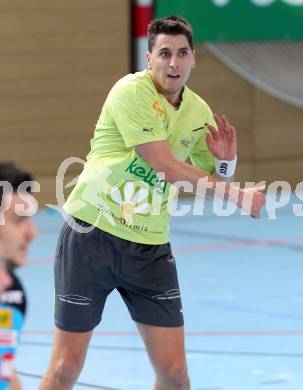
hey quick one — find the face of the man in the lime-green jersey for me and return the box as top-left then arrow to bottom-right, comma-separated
147,34 -> 195,104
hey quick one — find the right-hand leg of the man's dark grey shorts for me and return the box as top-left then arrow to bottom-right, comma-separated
118,243 -> 183,327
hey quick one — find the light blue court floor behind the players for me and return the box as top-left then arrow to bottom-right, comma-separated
17,196 -> 303,390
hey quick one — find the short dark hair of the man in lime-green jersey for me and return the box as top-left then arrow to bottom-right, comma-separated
147,16 -> 194,52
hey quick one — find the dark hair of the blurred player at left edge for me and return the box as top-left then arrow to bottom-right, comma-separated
0,162 -> 33,202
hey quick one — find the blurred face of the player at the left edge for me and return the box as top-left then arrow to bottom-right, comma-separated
0,193 -> 37,266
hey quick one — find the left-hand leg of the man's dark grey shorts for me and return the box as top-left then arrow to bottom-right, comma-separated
55,219 -> 115,332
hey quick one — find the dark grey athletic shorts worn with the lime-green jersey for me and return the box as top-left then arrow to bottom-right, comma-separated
55,217 -> 183,332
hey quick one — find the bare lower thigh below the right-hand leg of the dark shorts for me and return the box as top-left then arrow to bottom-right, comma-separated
137,323 -> 186,377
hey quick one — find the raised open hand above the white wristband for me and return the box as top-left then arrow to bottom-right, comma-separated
206,115 -> 237,160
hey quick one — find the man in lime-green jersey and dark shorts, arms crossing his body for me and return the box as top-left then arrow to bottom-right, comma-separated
40,17 -> 264,390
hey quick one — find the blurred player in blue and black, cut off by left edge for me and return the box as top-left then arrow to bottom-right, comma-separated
0,163 -> 37,390
